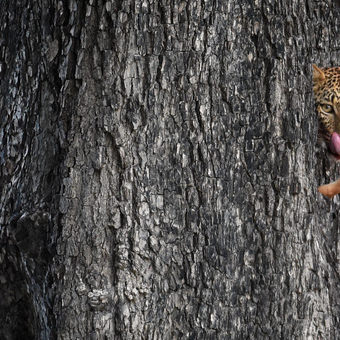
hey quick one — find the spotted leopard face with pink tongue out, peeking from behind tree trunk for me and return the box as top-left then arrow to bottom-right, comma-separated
313,65 -> 340,159
